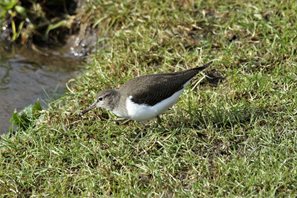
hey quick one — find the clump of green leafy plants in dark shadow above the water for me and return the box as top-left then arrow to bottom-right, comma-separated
0,0 -> 77,46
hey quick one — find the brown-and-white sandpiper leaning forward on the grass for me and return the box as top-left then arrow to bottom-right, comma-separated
80,61 -> 212,122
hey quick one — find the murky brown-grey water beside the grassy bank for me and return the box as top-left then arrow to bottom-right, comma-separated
0,44 -> 81,134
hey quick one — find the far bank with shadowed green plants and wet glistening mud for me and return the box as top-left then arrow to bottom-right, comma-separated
0,0 -> 97,57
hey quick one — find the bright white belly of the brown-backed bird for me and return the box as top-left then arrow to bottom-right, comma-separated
126,89 -> 183,121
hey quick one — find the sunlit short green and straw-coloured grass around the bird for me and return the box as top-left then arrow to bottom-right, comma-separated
0,0 -> 297,197
